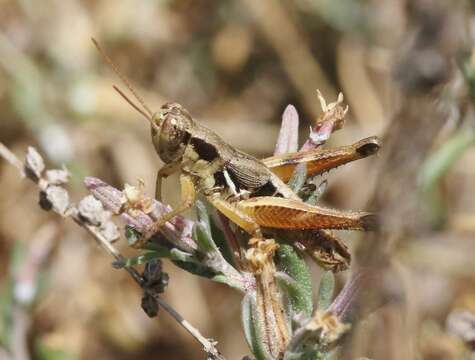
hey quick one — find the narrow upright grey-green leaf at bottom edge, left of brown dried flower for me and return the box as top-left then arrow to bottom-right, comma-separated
241,293 -> 271,360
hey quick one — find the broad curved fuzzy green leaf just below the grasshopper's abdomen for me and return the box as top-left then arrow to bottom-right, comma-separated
276,244 -> 313,317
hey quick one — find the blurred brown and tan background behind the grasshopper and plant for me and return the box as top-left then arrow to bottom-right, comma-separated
0,0 -> 475,360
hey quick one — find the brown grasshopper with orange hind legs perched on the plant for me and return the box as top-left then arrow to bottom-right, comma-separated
92,39 -> 379,270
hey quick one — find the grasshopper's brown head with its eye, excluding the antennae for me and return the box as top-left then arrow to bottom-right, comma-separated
152,103 -> 193,163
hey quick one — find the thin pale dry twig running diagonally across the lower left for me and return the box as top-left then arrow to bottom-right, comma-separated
0,142 -> 225,360
